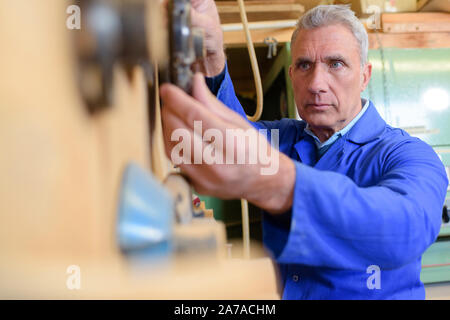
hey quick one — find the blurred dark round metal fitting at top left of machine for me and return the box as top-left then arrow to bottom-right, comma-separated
75,0 -> 154,112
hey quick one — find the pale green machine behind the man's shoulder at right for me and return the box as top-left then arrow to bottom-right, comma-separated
363,49 -> 450,283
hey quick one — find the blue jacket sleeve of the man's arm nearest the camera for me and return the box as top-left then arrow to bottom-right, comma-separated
276,139 -> 448,270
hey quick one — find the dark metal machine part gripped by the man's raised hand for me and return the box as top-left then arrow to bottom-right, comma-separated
168,0 -> 204,93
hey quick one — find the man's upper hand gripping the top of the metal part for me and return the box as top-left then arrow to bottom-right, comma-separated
191,0 -> 225,77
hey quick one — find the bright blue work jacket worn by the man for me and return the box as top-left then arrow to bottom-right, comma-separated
209,68 -> 448,299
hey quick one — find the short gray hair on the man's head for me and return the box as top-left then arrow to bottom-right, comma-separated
291,5 -> 369,66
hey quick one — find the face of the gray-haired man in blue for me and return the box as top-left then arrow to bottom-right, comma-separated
289,24 -> 371,132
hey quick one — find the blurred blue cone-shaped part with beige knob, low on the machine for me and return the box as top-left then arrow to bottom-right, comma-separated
116,163 -> 221,262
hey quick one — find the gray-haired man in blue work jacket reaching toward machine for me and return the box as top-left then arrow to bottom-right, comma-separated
161,0 -> 448,299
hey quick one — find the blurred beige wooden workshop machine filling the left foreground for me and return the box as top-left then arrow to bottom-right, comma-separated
0,0 -> 279,299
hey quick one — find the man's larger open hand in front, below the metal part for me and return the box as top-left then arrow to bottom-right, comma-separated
160,74 -> 295,213
